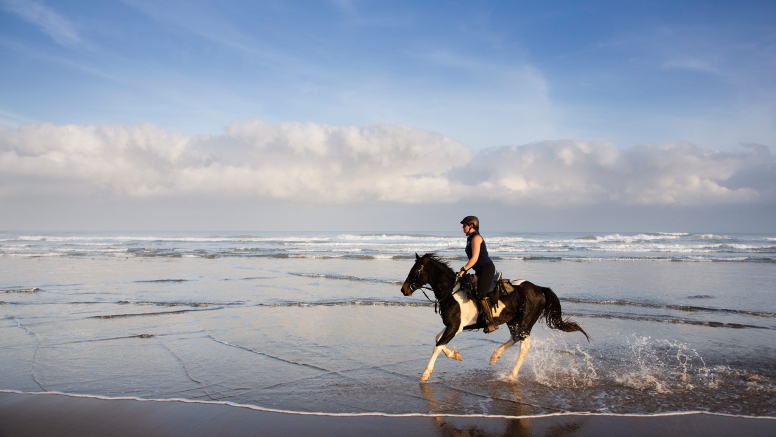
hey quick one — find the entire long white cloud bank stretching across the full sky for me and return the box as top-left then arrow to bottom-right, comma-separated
0,120 -> 776,206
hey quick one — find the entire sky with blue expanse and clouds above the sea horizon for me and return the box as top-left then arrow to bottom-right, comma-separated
0,0 -> 776,232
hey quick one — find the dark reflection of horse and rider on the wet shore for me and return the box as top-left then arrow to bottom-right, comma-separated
420,383 -> 588,437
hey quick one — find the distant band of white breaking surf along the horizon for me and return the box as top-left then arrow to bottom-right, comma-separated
0,232 -> 776,262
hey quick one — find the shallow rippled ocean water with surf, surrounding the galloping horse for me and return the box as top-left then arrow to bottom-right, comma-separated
0,231 -> 776,417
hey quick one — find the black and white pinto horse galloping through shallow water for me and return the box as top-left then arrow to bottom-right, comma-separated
401,253 -> 590,381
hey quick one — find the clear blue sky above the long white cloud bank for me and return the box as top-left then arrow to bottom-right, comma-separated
0,0 -> 776,149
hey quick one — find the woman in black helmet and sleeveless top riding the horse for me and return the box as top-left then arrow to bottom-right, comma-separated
458,215 -> 498,334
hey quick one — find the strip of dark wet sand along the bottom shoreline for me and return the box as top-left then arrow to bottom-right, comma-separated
0,393 -> 776,437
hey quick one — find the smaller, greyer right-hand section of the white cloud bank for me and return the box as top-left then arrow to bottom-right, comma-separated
461,140 -> 776,206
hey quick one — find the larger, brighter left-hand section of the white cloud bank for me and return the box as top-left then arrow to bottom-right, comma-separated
0,121 -> 471,203
